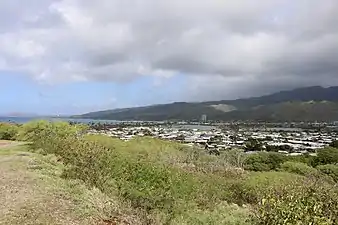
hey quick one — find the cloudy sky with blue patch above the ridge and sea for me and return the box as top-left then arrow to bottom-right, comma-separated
0,0 -> 338,115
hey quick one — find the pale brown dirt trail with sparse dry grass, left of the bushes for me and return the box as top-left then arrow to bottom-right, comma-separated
0,144 -> 107,225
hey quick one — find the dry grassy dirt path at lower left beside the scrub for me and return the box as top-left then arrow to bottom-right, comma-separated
0,142 -> 114,225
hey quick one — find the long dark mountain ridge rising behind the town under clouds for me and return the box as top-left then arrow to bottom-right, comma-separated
77,86 -> 338,121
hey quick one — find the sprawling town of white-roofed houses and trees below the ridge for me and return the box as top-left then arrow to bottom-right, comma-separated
89,122 -> 338,156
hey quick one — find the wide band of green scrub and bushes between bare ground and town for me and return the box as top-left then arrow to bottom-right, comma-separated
0,121 -> 338,225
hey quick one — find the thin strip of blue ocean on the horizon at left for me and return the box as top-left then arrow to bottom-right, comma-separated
0,117 -> 121,124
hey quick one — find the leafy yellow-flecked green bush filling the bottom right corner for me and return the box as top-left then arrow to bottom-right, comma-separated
256,181 -> 338,225
